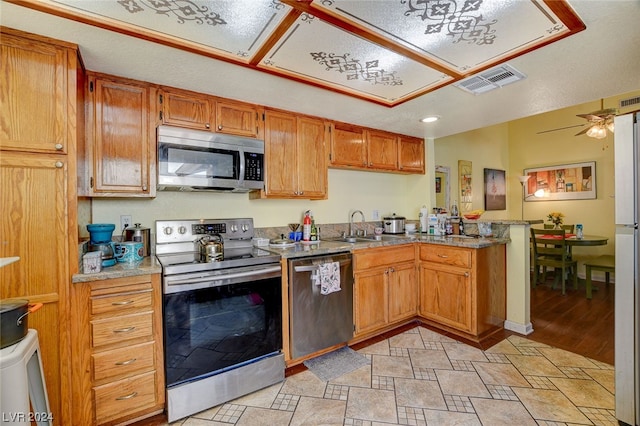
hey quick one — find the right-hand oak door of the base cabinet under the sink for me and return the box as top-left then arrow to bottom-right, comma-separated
389,263 -> 418,322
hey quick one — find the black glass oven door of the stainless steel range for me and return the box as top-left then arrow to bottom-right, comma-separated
164,277 -> 282,387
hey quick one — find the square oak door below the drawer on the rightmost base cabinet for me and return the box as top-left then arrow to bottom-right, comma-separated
420,262 -> 475,333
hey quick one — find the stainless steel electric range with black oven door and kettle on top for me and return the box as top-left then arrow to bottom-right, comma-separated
156,218 -> 285,422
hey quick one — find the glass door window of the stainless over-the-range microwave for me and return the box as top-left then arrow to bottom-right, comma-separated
158,143 -> 240,181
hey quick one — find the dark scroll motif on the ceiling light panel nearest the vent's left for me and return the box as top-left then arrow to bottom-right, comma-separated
310,52 -> 402,86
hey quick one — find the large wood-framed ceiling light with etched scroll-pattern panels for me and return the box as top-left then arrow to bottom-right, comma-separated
6,0 -> 585,107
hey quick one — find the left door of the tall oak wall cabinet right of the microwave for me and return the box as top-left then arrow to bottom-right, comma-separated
265,110 -> 298,198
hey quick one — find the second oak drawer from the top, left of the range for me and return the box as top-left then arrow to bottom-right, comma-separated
91,311 -> 153,347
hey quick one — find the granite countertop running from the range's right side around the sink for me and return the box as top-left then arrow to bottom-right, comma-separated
259,234 -> 511,259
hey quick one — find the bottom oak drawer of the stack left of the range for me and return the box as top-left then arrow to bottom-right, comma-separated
93,371 -> 156,424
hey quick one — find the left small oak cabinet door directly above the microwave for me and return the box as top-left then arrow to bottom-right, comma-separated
160,90 -> 215,130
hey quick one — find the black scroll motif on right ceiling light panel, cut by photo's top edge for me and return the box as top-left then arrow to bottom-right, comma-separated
400,0 -> 498,46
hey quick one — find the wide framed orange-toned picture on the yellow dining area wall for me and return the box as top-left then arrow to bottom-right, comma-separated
524,161 -> 596,201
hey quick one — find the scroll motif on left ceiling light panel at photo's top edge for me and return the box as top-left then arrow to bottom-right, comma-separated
118,0 -> 227,26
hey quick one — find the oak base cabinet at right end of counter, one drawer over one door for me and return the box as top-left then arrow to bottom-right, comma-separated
419,244 -> 506,341
